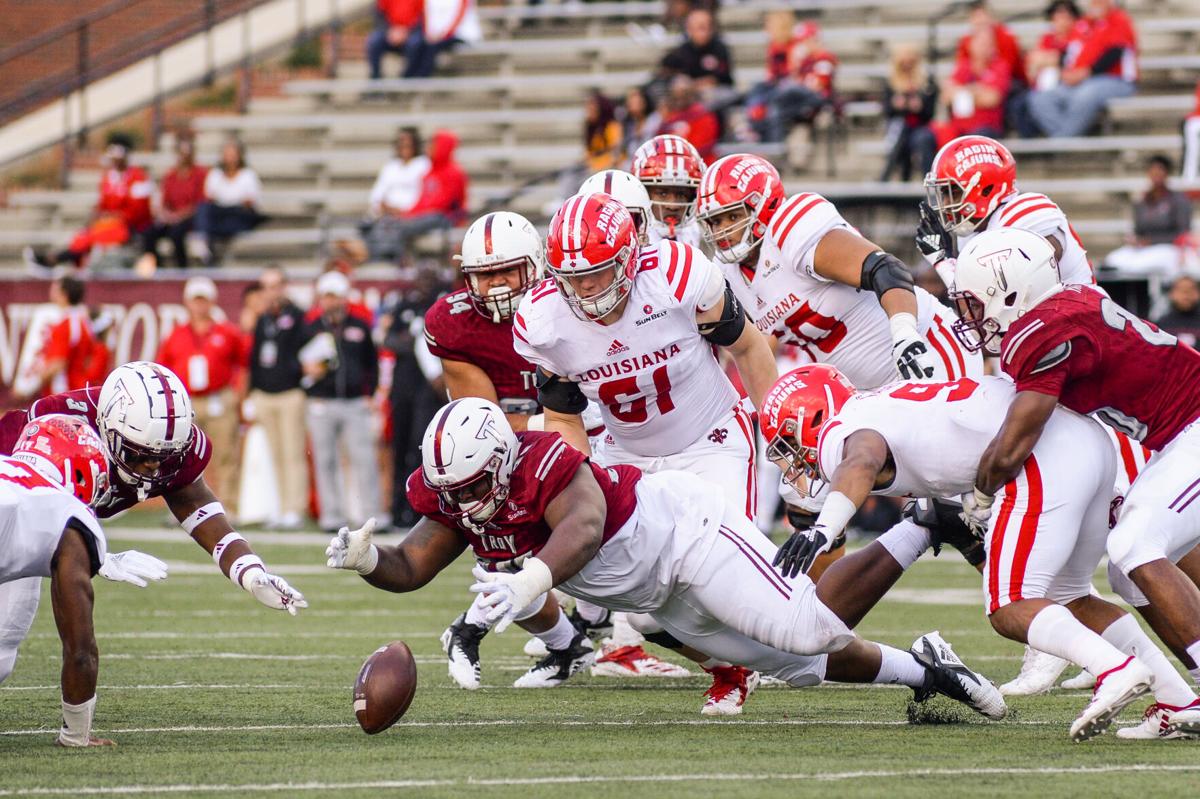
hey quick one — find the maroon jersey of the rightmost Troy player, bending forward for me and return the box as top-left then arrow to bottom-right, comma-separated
1001,286 -> 1200,450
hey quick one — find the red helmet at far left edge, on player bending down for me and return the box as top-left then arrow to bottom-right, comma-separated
12,414 -> 108,505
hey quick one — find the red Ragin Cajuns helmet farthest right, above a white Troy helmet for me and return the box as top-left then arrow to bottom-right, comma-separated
925,136 -> 1016,236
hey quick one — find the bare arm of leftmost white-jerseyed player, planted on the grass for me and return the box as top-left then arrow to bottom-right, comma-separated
50,525 -> 113,746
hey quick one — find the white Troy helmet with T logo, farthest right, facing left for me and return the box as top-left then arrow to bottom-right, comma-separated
950,228 -> 1062,355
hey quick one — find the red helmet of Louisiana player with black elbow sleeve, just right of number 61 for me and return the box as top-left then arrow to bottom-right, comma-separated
696,154 -> 786,264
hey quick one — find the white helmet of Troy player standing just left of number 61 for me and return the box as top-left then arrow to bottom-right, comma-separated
455,211 -> 546,322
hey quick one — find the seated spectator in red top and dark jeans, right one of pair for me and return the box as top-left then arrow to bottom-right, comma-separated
746,22 -> 838,142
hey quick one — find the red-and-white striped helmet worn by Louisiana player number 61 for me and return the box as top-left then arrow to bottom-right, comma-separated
546,192 -> 638,322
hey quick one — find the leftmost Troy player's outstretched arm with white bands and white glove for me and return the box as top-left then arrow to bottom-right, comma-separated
164,477 -> 308,615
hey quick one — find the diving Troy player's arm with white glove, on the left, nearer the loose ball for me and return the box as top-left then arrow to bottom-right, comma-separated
336,518 -> 467,594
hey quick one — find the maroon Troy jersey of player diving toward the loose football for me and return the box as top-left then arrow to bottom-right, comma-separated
408,431 -> 642,563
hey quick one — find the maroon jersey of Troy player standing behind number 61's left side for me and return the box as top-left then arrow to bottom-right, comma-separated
425,289 -> 540,414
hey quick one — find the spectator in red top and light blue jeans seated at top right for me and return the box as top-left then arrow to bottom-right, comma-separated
1030,0 -> 1138,137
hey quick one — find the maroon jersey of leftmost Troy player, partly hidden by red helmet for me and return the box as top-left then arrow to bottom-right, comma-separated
0,386 -> 212,518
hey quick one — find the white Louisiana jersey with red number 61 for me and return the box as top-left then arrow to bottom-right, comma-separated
512,241 -> 738,456
